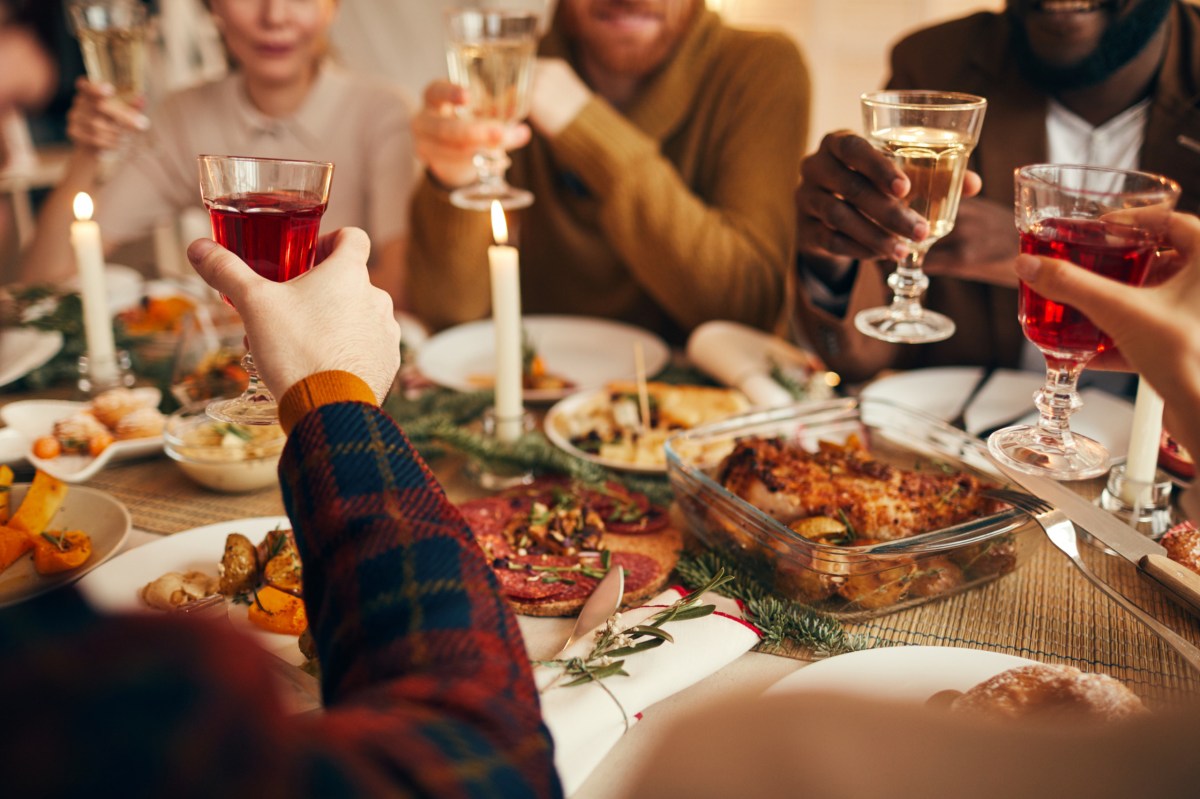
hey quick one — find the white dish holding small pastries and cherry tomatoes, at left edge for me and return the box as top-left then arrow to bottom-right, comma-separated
0,388 -> 162,482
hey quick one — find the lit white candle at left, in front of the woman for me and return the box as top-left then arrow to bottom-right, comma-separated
71,192 -> 119,386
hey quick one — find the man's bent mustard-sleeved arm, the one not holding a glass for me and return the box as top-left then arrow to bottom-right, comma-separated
542,36 -> 810,329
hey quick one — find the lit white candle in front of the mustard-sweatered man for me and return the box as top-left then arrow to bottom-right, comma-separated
487,195 -> 524,441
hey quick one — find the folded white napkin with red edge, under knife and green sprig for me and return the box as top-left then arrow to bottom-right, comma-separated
534,587 -> 761,794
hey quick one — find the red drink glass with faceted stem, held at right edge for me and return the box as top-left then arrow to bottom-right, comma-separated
988,164 -> 1180,480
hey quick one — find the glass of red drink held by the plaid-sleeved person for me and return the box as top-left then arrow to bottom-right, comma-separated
197,155 -> 334,425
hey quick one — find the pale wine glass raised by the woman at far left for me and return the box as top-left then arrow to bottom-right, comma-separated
68,0 -> 146,104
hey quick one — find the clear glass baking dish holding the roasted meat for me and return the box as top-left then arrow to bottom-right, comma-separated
666,400 -> 1036,620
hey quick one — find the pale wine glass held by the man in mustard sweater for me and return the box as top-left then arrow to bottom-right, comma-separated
446,8 -> 538,211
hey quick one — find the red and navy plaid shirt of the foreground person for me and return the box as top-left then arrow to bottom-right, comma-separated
0,402 -> 562,799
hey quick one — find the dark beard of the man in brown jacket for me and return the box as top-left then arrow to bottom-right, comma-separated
1007,0 -> 1174,92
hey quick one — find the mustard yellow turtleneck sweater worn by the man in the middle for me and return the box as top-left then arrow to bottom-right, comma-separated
408,10 -> 809,342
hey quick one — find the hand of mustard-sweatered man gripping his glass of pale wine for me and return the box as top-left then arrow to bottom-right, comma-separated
413,80 -> 529,188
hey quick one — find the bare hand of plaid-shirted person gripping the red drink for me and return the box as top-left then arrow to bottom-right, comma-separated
187,228 -> 400,402
